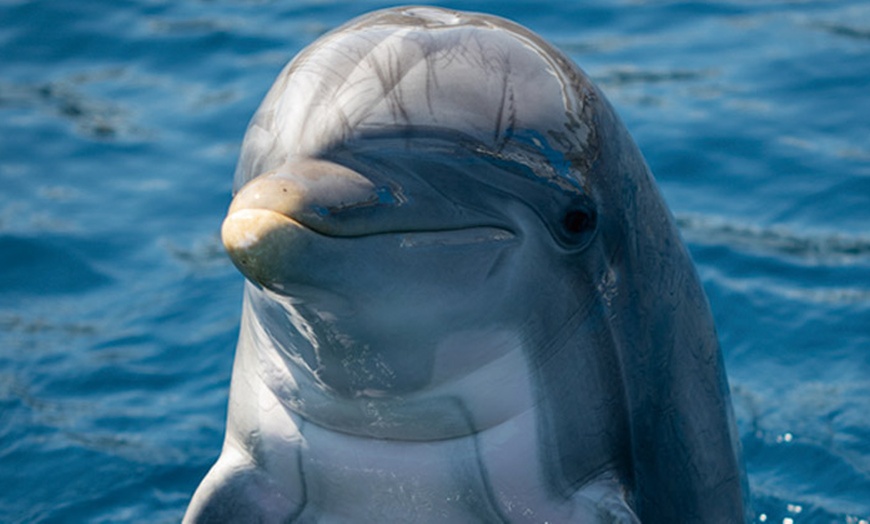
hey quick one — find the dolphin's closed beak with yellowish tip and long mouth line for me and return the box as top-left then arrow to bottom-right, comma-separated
221,160 -> 520,292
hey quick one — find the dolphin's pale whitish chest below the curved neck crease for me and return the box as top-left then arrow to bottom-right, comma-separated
290,411 -> 633,523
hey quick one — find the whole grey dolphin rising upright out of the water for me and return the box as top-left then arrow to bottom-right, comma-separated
185,8 -> 747,523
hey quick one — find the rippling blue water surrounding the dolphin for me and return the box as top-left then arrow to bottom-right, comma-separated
0,0 -> 870,524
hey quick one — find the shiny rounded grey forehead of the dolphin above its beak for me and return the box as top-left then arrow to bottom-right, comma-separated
235,7 -> 596,189
